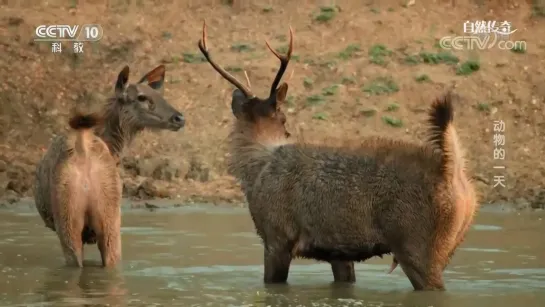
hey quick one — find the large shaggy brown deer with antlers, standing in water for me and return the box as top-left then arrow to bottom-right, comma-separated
199,23 -> 477,290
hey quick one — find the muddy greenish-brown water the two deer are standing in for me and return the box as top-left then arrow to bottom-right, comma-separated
0,206 -> 545,307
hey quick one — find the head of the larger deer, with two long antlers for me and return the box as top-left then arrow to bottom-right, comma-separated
198,22 -> 293,142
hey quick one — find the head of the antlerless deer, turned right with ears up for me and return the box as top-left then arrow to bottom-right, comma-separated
115,65 -> 185,131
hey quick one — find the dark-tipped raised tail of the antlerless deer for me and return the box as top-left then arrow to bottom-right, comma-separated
68,112 -> 102,157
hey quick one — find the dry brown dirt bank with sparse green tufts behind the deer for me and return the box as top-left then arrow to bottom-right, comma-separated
0,0 -> 545,211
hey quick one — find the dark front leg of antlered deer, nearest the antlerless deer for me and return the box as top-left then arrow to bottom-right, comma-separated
263,246 -> 291,284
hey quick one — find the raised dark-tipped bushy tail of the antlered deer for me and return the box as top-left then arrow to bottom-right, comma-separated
428,91 -> 465,179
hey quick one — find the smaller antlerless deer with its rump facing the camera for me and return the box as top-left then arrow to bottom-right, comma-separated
34,65 -> 185,267
